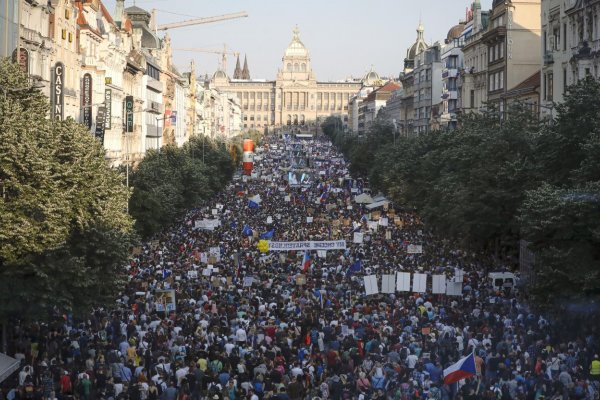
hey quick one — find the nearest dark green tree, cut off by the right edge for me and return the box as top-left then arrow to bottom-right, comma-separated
521,78 -> 600,306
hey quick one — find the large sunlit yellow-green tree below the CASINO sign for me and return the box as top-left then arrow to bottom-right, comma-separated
0,60 -> 133,318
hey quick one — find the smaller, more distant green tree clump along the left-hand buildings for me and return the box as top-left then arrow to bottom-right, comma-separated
129,137 -> 235,238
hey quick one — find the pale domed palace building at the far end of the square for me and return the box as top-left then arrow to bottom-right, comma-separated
210,27 -> 362,129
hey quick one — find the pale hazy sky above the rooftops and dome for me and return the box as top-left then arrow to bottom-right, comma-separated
104,0 -> 492,81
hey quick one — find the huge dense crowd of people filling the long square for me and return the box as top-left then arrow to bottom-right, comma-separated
2,137 -> 600,400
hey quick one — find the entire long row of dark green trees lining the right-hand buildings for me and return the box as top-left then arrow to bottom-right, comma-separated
323,78 -> 600,305
